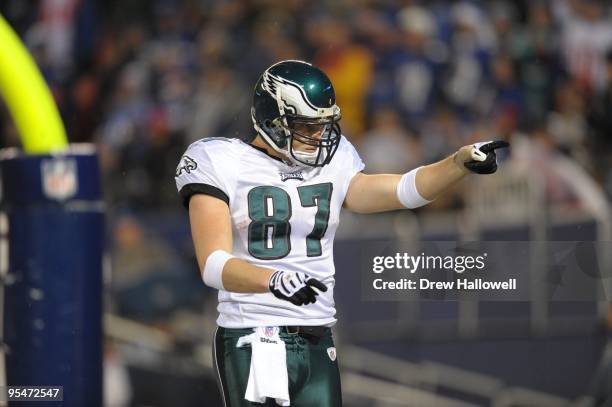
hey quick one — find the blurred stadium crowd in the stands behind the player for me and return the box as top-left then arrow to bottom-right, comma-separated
0,0 -> 612,210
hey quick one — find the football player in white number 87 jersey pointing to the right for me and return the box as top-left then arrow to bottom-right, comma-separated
176,60 -> 507,407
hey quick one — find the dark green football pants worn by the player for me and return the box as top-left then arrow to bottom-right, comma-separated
213,327 -> 342,407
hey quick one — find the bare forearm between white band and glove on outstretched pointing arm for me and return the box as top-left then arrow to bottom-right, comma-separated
416,154 -> 469,201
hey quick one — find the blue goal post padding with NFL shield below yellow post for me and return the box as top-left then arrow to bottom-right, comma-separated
0,146 -> 104,406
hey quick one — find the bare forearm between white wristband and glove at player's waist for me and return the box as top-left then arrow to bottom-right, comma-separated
222,257 -> 275,293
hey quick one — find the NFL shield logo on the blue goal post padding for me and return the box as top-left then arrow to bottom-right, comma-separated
40,158 -> 77,201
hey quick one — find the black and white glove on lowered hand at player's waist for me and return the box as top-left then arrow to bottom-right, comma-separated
268,271 -> 327,305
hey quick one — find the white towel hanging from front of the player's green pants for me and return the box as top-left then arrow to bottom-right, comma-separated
236,327 -> 290,406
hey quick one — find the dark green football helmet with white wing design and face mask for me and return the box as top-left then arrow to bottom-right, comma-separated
251,60 -> 341,167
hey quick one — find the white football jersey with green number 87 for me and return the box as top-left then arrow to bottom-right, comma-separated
176,136 -> 364,328
